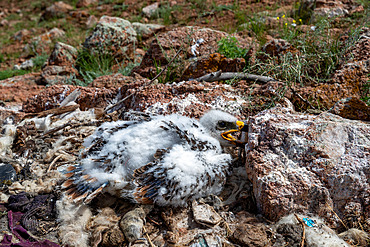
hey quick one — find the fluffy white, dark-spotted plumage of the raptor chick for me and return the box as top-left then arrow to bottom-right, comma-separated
62,110 -> 244,206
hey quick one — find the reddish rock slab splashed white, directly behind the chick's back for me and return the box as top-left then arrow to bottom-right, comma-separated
118,80 -> 247,118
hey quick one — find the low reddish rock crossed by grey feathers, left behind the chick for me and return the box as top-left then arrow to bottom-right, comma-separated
22,85 -> 117,113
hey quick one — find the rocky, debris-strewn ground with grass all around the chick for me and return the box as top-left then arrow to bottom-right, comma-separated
0,0 -> 370,246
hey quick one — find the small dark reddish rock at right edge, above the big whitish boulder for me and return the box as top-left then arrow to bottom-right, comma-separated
328,97 -> 370,121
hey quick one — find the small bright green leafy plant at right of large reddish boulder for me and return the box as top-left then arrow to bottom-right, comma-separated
217,36 -> 247,58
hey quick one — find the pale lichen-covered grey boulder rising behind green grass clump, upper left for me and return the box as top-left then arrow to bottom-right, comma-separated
83,16 -> 137,60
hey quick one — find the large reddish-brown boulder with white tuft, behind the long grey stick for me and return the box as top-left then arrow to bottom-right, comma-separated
133,26 -> 252,78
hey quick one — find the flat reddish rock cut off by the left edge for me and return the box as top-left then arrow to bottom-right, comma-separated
0,73 -> 45,105
